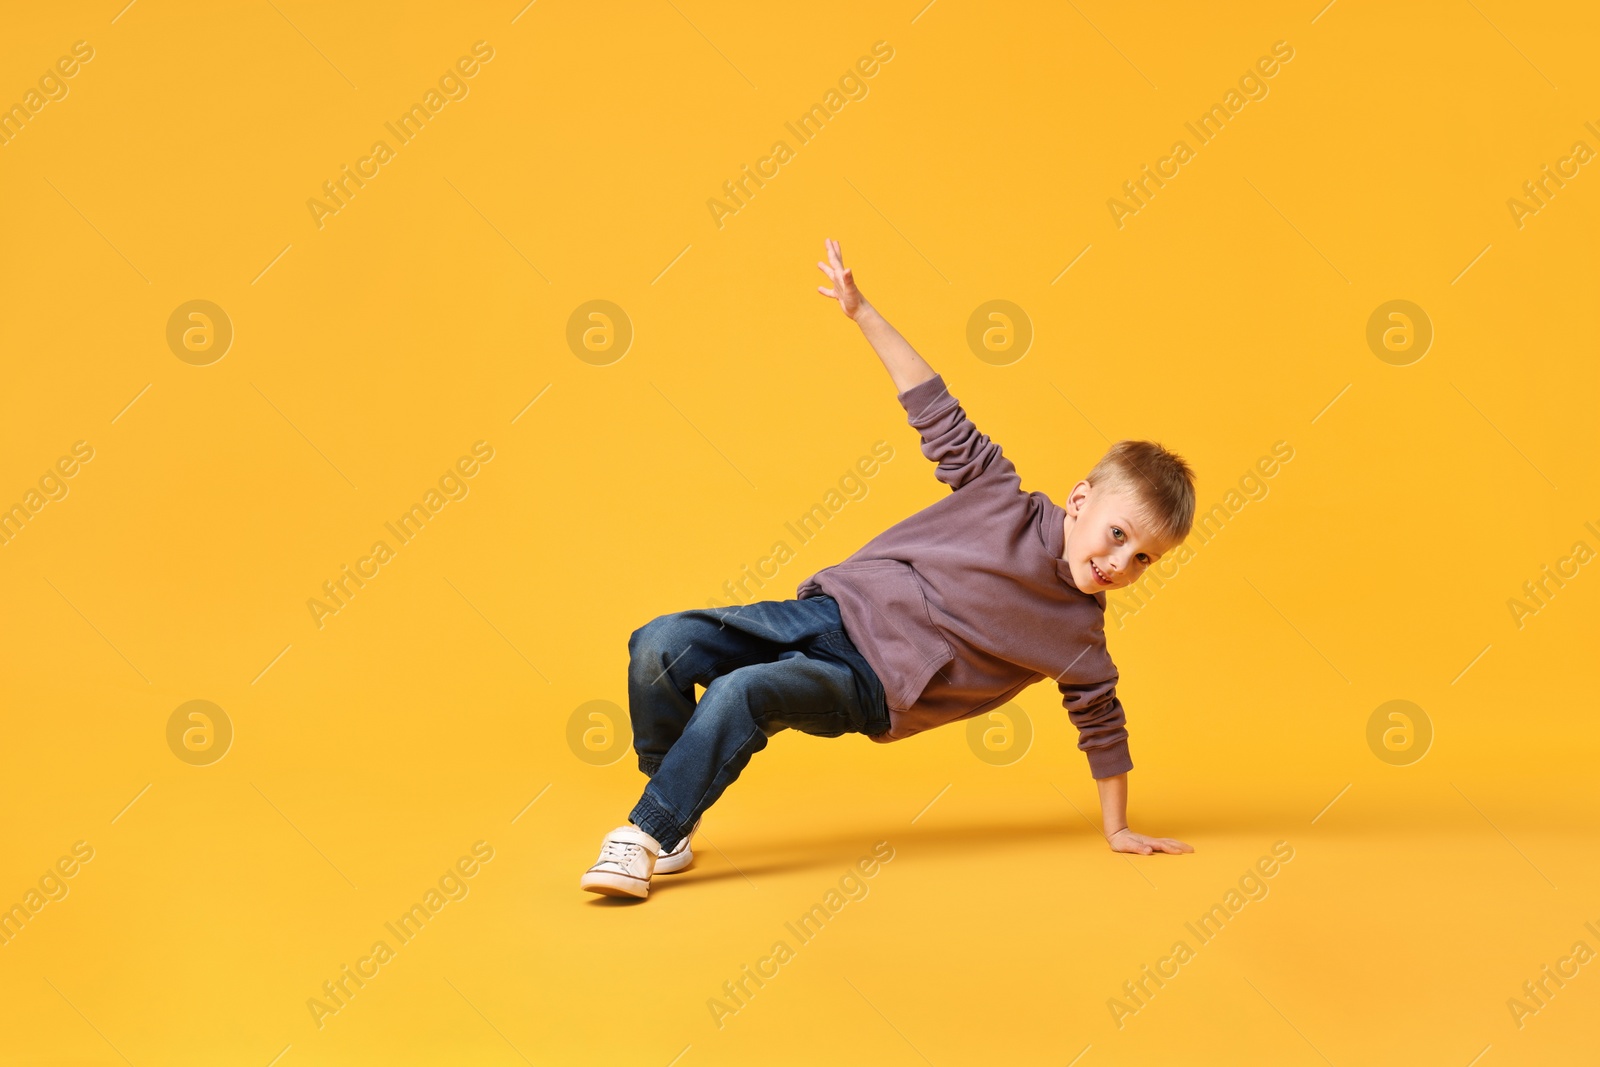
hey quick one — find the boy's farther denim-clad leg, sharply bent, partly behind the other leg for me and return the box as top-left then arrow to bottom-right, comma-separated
627,597 -> 840,777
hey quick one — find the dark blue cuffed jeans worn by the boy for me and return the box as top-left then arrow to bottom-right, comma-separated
627,595 -> 890,849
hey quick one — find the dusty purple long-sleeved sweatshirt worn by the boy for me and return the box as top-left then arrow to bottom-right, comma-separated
797,374 -> 1133,777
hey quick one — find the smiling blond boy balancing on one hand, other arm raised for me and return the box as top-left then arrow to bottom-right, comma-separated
579,240 -> 1194,897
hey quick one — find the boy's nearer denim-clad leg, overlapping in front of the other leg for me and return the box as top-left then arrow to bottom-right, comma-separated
629,632 -> 886,848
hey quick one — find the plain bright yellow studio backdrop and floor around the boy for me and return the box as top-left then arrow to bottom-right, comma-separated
0,0 -> 1600,1067
